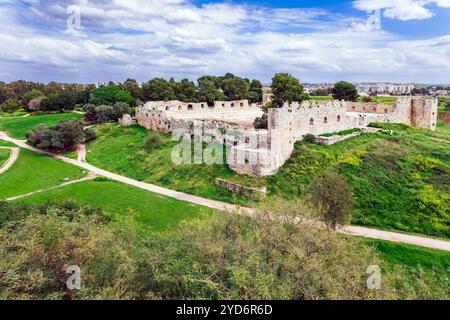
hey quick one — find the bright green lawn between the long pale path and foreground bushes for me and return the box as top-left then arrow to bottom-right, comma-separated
20,179 -> 213,231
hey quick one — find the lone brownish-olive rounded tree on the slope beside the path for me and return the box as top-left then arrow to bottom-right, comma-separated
309,171 -> 353,229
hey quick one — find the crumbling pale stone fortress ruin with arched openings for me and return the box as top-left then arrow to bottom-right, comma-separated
136,97 -> 438,177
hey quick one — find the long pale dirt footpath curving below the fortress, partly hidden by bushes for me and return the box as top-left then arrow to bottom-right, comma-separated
0,131 -> 450,251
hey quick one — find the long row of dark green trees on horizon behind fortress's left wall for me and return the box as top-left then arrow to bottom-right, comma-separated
0,73 -> 263,113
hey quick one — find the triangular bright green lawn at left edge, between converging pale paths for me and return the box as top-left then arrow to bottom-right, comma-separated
0,149 -> 86,199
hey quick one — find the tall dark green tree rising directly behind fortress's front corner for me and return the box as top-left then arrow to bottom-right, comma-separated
272,73 -> 305,108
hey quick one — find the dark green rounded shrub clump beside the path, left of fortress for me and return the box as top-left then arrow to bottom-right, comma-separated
27,119 -> 95,152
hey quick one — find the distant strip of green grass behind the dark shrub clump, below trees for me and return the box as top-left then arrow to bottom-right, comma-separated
0,113 -> 83,139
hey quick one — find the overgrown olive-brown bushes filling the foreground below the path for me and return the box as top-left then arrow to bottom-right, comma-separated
0,202 -> 450,300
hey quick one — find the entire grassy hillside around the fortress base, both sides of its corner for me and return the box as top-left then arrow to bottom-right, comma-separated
88,109 -> 450,238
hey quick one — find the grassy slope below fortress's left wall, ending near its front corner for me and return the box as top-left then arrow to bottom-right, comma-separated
87,124 -> 264,204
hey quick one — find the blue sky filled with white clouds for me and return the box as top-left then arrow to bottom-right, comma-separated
0,0 -> 450,83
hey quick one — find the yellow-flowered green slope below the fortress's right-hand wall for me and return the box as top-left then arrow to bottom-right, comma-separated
269,120 -> 450,238
